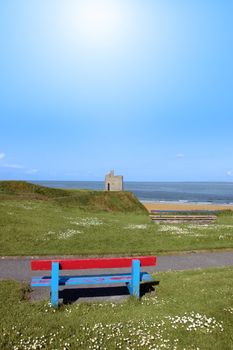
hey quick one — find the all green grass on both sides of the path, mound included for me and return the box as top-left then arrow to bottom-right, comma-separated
0,182 -> 233,350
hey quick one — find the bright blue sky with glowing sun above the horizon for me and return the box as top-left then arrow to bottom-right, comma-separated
0,0 -> 233,181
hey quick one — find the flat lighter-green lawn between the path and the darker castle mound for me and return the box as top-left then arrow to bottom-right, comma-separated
0,199 -> 233,256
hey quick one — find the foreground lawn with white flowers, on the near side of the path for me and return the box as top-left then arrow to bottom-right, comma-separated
0,268 -> 233,350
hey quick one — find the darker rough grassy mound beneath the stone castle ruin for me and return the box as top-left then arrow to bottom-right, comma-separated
0,181 -> 146,213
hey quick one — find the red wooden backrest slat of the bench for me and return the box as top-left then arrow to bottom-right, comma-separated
31,256 -> 156,270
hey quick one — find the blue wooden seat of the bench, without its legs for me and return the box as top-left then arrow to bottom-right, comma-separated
31,272 -> 153,287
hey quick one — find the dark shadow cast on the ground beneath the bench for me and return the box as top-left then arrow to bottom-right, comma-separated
59,281 -> 159,304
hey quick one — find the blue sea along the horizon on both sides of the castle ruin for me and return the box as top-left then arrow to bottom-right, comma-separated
32,181 -> 233,205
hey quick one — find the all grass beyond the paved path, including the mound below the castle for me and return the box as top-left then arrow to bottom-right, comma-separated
0,181 -> 233,256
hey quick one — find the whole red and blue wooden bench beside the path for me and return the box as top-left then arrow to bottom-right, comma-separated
31,256 -> 156,307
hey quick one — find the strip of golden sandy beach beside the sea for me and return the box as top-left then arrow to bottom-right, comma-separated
142,202 -> 233,212
